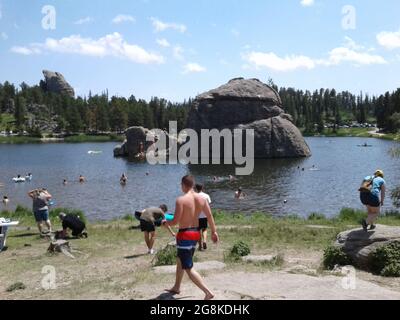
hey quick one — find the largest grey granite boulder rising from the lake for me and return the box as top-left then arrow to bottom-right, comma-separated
187,78 -> 311,158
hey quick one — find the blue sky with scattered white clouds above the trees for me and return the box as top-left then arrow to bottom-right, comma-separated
0,0 -> 400,101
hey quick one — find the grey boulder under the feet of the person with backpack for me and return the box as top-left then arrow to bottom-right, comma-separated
335,225 -> 400,270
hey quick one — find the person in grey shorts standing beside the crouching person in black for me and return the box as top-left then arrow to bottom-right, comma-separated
28,189 -> 51,234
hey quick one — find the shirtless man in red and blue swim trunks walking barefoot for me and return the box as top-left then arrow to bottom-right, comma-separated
163,175 -> 219,300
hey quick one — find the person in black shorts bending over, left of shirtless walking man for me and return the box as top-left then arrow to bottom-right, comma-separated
139,204 -> 175,254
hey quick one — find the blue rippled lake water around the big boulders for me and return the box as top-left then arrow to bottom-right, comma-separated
0,138 -> 400,220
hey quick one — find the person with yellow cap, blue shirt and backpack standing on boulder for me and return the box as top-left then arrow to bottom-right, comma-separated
360,170 -> 386,231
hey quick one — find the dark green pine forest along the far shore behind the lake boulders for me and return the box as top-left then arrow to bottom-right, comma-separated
0,79 -> 400,135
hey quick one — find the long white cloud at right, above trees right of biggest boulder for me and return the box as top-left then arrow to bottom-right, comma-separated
242,37 -> 387,72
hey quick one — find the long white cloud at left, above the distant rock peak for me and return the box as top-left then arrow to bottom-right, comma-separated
11,32 -> 164,64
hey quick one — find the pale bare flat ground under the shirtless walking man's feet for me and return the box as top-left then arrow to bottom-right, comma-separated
136,272 -> 400,300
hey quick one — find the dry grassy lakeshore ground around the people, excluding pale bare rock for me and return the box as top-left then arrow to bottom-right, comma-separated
0,207 -> 400,299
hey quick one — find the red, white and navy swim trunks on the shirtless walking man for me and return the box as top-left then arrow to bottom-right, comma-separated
176,228 -> 200,270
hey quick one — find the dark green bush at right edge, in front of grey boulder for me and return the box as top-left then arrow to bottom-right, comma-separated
370,241 -> 400,277
